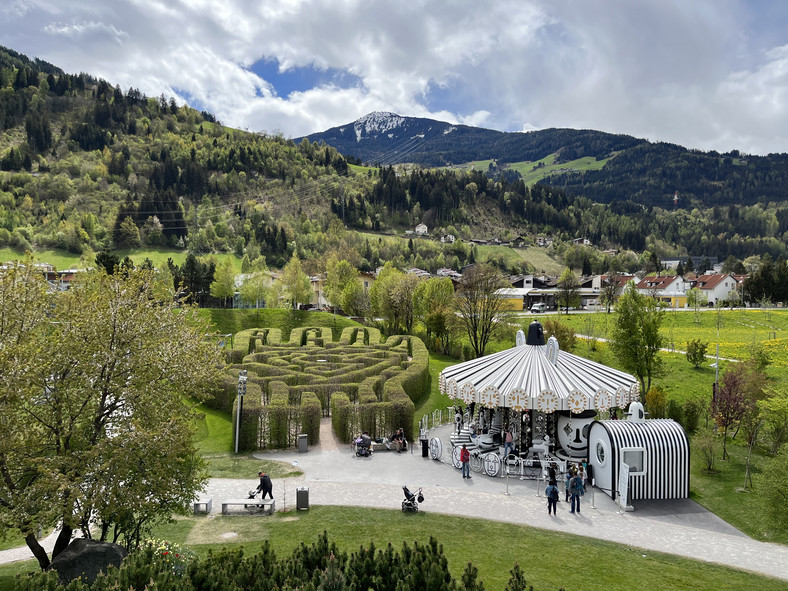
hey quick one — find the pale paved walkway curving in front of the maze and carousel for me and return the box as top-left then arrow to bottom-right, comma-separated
0,419 -> 788,580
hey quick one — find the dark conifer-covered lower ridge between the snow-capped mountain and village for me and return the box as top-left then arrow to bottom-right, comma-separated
364,168 -> 788,260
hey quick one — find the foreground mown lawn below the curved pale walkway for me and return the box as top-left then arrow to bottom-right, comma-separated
0,506 -> 788,591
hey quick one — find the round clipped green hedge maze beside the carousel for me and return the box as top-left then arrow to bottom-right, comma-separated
212,327 -> 430,451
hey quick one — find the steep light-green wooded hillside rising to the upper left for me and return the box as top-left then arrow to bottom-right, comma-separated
0,50 -> 370,268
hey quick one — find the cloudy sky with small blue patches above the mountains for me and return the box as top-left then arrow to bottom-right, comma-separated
0,0 -> 788,154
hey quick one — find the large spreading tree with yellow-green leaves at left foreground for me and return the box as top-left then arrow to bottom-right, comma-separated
0,263 -> 222,568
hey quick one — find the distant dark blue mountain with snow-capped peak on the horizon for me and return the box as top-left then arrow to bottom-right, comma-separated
298,112 -> 788,209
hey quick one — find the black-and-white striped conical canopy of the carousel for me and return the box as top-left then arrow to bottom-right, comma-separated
440,322 -> 638,414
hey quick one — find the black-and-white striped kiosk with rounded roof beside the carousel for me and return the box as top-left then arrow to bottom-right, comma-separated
588,402 -> 690,500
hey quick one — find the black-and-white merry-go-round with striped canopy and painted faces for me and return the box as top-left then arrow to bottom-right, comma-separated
430,321 -> 639,478
